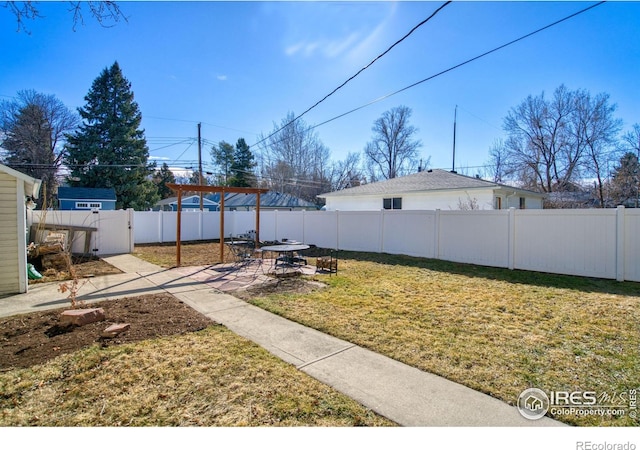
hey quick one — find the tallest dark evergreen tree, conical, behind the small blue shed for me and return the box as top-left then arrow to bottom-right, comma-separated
65,62 -> 160,210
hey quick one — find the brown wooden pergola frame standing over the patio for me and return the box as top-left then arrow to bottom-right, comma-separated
167,183 -> 269,267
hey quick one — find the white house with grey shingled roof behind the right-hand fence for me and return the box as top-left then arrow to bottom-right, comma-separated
318,169 -> 545,211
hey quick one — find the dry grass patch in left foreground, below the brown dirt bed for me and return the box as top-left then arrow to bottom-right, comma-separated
0,326 -> 394,426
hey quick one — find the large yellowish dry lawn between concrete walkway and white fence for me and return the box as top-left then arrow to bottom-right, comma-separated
242,252 -> 640,426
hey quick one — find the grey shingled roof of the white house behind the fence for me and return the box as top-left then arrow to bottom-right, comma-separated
318,169 -> 543,198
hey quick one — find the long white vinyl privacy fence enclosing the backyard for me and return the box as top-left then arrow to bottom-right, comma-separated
29,207 -> 640,281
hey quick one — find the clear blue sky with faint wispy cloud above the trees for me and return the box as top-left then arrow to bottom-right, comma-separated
0,1 -> 640,175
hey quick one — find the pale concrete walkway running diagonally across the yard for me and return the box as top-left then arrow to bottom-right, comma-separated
0,255 -> 563,427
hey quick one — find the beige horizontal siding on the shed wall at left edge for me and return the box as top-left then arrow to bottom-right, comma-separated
0,173 -> 20,294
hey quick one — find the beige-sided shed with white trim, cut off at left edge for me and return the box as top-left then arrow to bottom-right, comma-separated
0,164 -> 41,295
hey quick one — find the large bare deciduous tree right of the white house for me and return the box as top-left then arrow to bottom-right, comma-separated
492,85 -> 621,207
